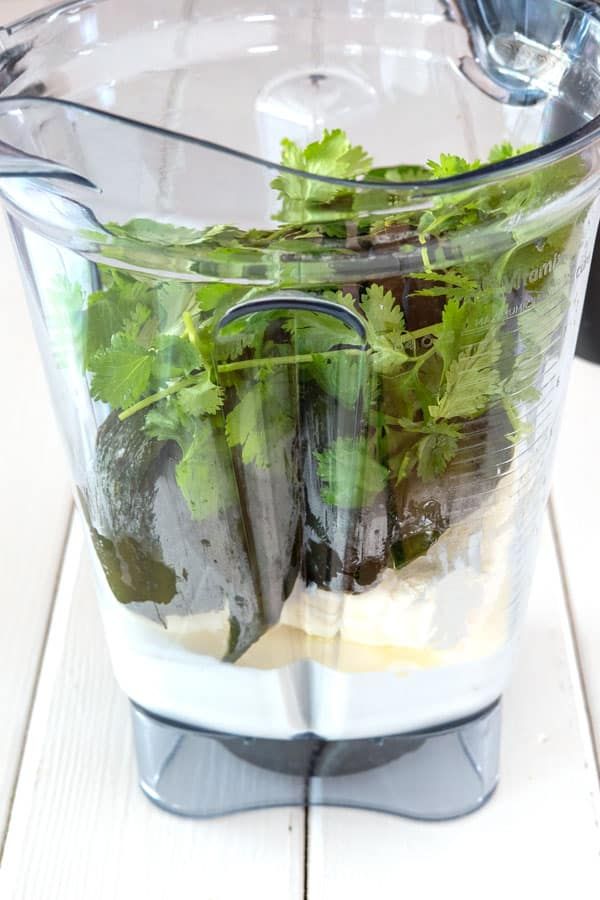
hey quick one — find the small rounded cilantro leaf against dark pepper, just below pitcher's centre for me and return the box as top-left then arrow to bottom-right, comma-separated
315,438 -> 388,509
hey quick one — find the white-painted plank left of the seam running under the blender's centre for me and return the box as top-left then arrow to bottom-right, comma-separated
0,525 -> 304,900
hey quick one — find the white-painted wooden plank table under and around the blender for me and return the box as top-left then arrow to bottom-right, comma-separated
0,0 -> 600,884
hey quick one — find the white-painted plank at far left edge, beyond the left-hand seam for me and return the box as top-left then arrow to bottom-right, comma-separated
0,207 -> 71,849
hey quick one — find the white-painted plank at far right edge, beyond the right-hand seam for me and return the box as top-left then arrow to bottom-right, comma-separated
552,360 -> 600,748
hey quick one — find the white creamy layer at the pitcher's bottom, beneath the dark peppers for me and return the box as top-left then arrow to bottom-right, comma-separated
100,479 -> 512,739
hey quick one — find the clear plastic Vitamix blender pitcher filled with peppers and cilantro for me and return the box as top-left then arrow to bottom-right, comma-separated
0,0 -> 600,818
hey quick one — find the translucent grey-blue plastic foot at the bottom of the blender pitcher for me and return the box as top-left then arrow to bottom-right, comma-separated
132,701 -> 500,819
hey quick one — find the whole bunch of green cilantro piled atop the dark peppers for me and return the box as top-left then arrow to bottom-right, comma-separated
50,129 -> 582,519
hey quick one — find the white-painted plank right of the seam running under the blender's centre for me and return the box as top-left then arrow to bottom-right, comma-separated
308,527 -> 600,900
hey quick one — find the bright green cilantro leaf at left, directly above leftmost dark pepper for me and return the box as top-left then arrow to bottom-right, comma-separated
91,335 -> 153,409
